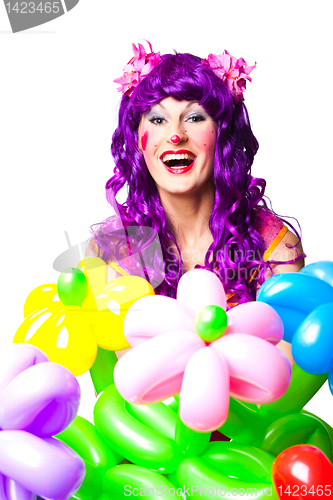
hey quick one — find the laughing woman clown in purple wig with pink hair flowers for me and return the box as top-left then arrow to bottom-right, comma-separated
87,44 -> 304,358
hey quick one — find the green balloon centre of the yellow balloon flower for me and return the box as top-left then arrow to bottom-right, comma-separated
58,267 -> 88,307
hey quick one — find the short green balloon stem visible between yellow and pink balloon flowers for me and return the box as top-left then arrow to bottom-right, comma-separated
89,347 -> 118,394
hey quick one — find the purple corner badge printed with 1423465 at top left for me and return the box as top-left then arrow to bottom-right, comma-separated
4,0 -> 80,33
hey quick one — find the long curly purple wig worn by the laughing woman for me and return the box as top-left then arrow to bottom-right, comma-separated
91,53 -> 301,303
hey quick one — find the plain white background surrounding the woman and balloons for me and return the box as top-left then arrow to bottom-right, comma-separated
0,0 -> 333,425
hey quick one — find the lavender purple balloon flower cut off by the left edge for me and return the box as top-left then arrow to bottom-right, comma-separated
0,344 -> 85,500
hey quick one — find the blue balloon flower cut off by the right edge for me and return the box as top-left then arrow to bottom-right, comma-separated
257,261 -> 333,375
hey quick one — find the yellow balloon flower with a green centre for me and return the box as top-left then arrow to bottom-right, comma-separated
13,257 -> 154,376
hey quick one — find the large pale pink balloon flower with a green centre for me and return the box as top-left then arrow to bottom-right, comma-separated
114,269 -> 291,432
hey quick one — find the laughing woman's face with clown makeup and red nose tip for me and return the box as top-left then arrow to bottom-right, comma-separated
139,97 -> 217,195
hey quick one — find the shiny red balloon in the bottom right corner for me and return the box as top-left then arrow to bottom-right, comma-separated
272,444 -> 333,500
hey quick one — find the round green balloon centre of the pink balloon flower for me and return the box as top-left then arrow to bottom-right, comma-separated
194,305 -> 228,342
